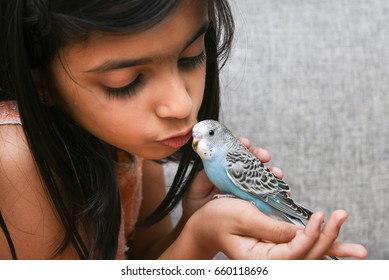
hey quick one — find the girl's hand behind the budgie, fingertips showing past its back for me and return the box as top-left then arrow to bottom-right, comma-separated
182,137 -> 274,219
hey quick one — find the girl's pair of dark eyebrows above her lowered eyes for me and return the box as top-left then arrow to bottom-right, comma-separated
85,21 -> 209,73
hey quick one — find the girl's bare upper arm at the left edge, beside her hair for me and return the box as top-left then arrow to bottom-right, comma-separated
0,106 -> 71,259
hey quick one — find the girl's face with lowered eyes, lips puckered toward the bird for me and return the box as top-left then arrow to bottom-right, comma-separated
51,1 -> 208,159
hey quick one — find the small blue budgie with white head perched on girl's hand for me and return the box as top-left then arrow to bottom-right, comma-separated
192,120 -> 336,259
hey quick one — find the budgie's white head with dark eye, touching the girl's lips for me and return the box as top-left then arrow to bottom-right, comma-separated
192,120 -> 234,160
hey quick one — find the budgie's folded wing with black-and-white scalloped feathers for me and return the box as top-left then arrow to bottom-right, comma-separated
226,146 -> 312,220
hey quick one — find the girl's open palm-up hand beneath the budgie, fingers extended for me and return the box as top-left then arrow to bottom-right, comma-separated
182,198 -> 367,259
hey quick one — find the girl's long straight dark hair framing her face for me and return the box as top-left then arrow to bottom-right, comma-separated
0,0 -> 234,259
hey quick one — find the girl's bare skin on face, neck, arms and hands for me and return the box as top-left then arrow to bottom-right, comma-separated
0,1 -> 367,259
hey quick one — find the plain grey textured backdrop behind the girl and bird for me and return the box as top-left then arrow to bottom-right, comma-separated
167,0 -> 389,259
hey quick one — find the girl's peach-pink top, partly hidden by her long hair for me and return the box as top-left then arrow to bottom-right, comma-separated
0,101 -> 143,259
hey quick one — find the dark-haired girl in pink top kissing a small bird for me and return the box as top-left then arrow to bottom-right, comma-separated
0,0 -> 366,259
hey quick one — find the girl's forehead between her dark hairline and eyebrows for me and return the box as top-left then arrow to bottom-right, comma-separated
56,1 -> 208,71
